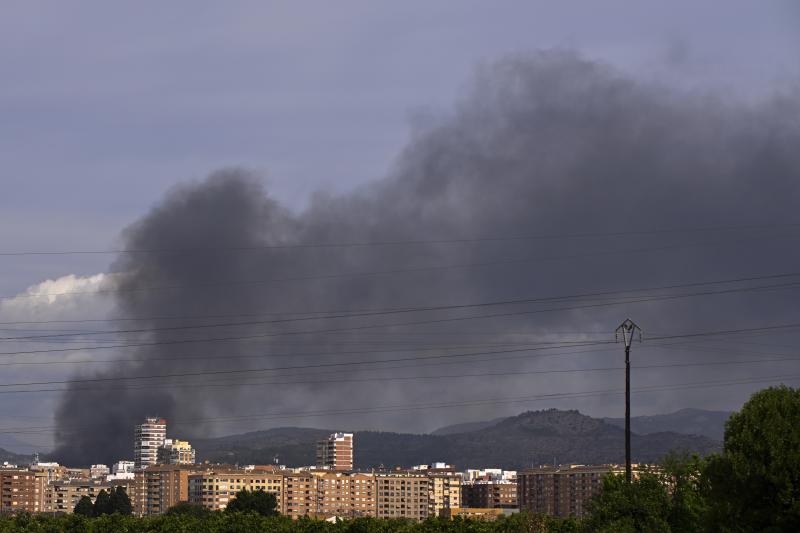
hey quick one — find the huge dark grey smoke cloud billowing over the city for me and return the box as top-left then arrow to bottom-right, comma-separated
55,51 -> 800,464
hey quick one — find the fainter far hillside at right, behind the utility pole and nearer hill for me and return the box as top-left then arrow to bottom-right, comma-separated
603,409 -> 731,442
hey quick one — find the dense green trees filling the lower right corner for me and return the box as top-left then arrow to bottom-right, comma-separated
583,386 -> 800,532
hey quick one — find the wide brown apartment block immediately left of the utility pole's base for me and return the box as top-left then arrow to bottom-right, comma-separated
517,465 -> 624,517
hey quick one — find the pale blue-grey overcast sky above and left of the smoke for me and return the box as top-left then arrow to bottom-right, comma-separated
0,0 -> 800,454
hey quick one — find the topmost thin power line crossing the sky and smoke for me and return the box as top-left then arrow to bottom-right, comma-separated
0,218 -> 800,257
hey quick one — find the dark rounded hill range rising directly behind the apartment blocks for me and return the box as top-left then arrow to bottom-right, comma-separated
193,409 -> 719,469
